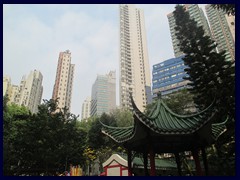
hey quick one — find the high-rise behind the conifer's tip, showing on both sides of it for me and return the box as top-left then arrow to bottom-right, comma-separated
167,4 -> 212,57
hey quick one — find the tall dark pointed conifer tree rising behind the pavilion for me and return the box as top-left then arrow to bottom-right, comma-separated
174,5 -> 235,121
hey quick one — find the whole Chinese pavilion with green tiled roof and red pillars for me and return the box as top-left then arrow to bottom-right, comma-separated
102,95 -> 226,176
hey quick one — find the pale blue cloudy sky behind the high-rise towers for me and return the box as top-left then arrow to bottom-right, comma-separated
3,4 -> 207,117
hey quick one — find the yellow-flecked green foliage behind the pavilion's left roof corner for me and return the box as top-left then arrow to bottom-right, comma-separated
85,112 -> 133,174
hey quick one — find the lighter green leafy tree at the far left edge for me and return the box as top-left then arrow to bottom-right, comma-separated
3,97 -> 31,175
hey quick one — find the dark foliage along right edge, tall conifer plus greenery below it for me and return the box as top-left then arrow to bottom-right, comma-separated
174,5 -> 235,175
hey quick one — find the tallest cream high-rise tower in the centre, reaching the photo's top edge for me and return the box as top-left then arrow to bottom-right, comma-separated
119,4 -> 151,111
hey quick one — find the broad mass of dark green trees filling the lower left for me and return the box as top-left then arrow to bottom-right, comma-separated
3,100 -> 87,175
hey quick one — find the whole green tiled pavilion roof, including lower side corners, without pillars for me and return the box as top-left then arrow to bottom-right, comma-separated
102,95 -> 226,148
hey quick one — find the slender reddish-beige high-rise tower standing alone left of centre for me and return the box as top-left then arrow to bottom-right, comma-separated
52,50 -> 75,112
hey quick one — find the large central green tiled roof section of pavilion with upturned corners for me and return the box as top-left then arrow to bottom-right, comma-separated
132,96 -> 214,134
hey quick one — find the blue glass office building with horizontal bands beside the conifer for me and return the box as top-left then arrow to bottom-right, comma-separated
152,56 -> 188,98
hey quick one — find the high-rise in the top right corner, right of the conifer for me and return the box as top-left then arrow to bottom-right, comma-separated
205,4 -> 235,61
